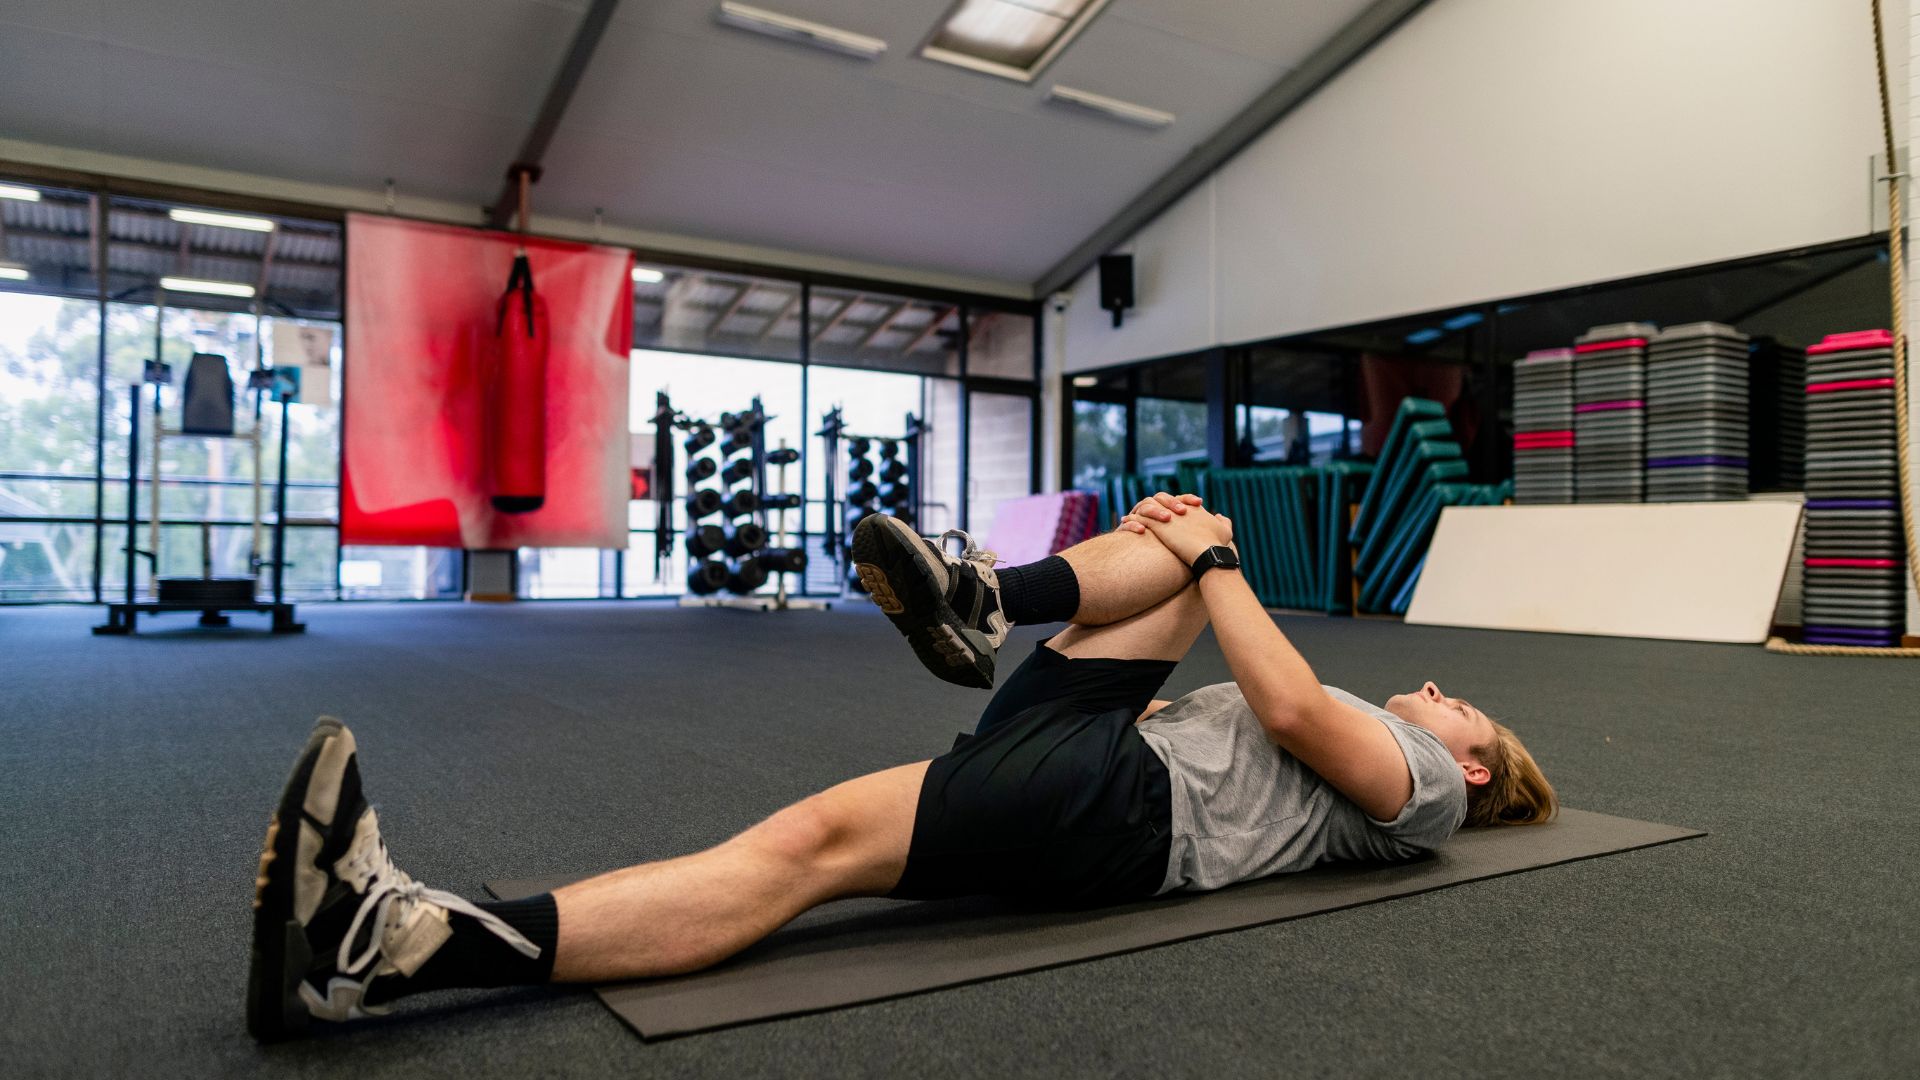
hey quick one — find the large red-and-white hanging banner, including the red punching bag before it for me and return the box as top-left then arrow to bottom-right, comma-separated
340,213 -> 634,550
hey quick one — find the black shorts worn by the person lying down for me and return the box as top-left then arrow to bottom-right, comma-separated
891,642 -> 1175,907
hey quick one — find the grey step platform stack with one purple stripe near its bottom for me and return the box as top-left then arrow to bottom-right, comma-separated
1645,323 -> 1749,502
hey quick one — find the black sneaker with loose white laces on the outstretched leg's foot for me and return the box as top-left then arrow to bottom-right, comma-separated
246,717 -> 540,1042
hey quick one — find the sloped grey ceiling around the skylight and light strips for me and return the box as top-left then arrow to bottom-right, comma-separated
0,0 -> 1369,284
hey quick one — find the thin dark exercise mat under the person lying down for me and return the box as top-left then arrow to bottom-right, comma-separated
486,811 -> 1705,1040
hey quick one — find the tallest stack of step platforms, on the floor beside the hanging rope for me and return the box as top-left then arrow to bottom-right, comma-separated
1805,331 -> 1907,646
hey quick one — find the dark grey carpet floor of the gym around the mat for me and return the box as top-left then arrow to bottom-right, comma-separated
0,603 -> 1920,1080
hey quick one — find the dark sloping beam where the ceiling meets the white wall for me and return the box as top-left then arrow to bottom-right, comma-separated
1033,0 -> 1428,300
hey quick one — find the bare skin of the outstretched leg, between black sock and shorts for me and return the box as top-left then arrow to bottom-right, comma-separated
553,761 -> 927,982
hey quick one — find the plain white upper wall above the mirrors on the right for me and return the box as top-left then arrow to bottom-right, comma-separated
1066,0 -> 1907,371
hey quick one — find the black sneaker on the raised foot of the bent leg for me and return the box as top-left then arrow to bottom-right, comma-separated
852,515 -> 1010,690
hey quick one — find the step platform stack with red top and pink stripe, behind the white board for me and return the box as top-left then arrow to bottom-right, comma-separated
1572,323 -> 1659,502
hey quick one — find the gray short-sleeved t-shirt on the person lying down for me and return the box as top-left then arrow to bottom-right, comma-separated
1139,682 -> 1467,892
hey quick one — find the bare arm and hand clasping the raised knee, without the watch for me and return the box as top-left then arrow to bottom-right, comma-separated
1144,511 -> 1413,821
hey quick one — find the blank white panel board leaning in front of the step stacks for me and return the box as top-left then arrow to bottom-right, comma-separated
1407,502 -> 1801,644
